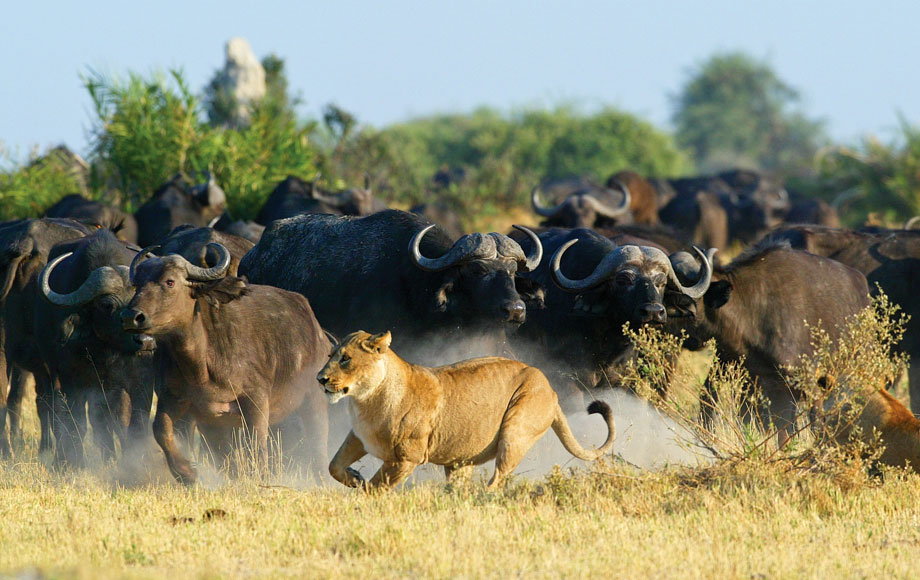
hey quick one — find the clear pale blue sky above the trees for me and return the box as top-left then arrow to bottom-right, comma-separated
0,0 -> 920,159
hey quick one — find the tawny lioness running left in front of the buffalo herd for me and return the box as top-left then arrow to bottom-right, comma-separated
316,331 -> 614,489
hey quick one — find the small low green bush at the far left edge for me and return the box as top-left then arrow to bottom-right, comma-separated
0,145 -> 83,220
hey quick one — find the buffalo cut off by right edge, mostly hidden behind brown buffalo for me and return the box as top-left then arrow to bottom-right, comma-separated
762,225 -> 920,415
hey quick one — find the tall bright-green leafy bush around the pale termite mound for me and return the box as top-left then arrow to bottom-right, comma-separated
85,66 -> 315,218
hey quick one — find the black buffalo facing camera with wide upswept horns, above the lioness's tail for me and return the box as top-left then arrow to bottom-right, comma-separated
515,228 -> 711,404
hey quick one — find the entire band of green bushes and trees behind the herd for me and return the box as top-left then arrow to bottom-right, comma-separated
0,55 -> 920,225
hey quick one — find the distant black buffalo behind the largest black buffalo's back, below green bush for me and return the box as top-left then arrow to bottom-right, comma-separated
256,175 -> 386,226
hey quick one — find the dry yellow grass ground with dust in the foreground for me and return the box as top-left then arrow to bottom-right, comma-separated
0,322 -> 920,578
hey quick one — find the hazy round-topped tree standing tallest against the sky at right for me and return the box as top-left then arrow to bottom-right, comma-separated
672,52 -> 827,175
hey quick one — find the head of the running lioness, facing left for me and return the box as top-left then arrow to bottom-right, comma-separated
316,330 -> 393,403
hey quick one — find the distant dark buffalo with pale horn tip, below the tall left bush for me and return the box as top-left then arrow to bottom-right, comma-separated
134,175 -> 227,247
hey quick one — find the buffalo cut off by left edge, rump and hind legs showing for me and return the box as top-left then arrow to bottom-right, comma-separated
0,218 -> 95,455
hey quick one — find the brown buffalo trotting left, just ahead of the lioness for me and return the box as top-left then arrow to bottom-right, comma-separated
121,244 -> 332,484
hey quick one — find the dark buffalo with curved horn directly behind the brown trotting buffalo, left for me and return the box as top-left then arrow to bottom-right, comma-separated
35,230 -> 155,466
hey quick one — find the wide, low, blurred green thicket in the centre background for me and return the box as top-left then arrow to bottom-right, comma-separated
323,107 -> 690,221
